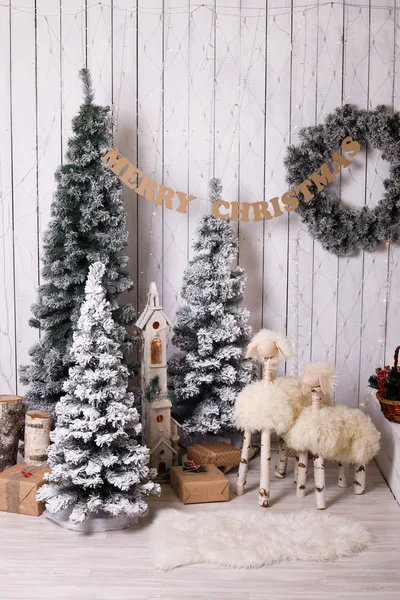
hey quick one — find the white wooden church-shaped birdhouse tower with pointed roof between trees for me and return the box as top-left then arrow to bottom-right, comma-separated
136,282 -> 179,475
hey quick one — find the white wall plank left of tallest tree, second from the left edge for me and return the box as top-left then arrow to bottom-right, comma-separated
10,0 -> 39,398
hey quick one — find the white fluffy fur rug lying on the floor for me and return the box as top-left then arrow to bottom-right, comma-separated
152,509 -> 370,571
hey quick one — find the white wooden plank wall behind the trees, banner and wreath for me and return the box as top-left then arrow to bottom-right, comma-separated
0,0 -> 400,406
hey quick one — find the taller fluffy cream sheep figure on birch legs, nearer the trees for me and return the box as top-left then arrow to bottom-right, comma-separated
235,329 -> 304,507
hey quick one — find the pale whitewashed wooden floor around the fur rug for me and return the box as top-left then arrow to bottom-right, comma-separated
0,459 -> 400,600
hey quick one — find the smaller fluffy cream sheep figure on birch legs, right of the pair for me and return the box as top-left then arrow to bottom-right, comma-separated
284,362 -> 380,508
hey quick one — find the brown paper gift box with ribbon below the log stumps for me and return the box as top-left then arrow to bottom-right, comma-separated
0,465 -> 49,517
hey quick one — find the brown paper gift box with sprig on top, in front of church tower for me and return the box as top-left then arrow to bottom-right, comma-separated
171,465 -> 229,504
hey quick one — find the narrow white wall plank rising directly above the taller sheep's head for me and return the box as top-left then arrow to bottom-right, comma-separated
262,0 -> 293,356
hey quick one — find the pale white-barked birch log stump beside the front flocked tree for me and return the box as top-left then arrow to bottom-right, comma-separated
25,410 -> 51,467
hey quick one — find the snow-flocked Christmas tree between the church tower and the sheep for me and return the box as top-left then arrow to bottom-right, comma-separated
169,179 -> 252,433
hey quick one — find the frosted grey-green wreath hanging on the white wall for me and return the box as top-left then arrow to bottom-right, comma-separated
285,104 -> 400,256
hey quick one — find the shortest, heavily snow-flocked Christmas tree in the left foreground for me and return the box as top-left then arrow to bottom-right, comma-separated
38,262 -> 159,524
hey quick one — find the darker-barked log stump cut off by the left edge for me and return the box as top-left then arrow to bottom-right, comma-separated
0,395 -> 24,472
